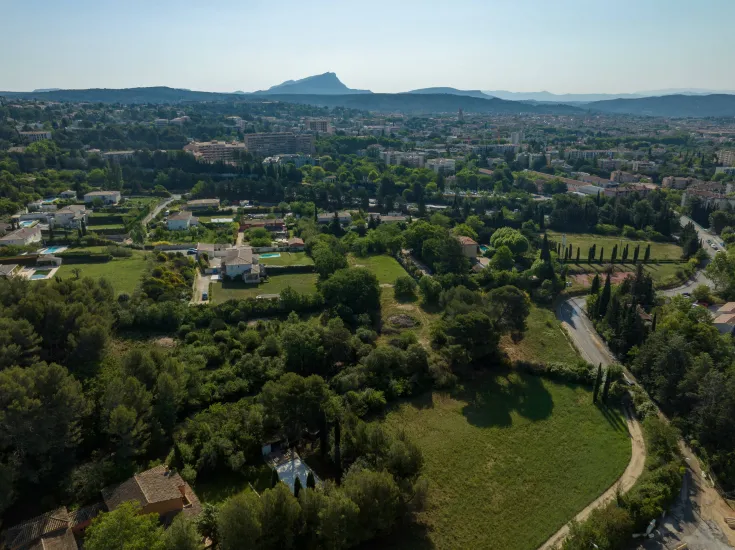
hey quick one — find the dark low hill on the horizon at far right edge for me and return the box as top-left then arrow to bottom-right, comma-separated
584,94 -> 735,117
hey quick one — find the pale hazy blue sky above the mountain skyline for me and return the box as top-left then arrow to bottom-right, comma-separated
0,0 -> 735,93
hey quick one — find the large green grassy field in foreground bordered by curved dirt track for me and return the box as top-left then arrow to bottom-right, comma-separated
380,373 -> 631,550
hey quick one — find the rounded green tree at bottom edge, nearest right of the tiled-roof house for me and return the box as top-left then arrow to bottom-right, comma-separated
217,492 -> 262,550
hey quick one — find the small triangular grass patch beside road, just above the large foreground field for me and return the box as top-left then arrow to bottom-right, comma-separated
500,306 -> 579,363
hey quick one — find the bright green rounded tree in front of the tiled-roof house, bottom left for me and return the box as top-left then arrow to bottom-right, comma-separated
84,501 -> 166,550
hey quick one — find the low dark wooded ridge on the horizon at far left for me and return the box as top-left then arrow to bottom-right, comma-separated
0,86 -> 243,103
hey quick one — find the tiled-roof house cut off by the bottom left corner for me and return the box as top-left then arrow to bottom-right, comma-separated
0,506 -> 79,550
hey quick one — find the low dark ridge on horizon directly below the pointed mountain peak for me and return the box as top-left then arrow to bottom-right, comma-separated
269,94 -> 583,114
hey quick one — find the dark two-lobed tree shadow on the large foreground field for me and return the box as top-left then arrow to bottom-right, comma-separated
459,373 -> 554,428
